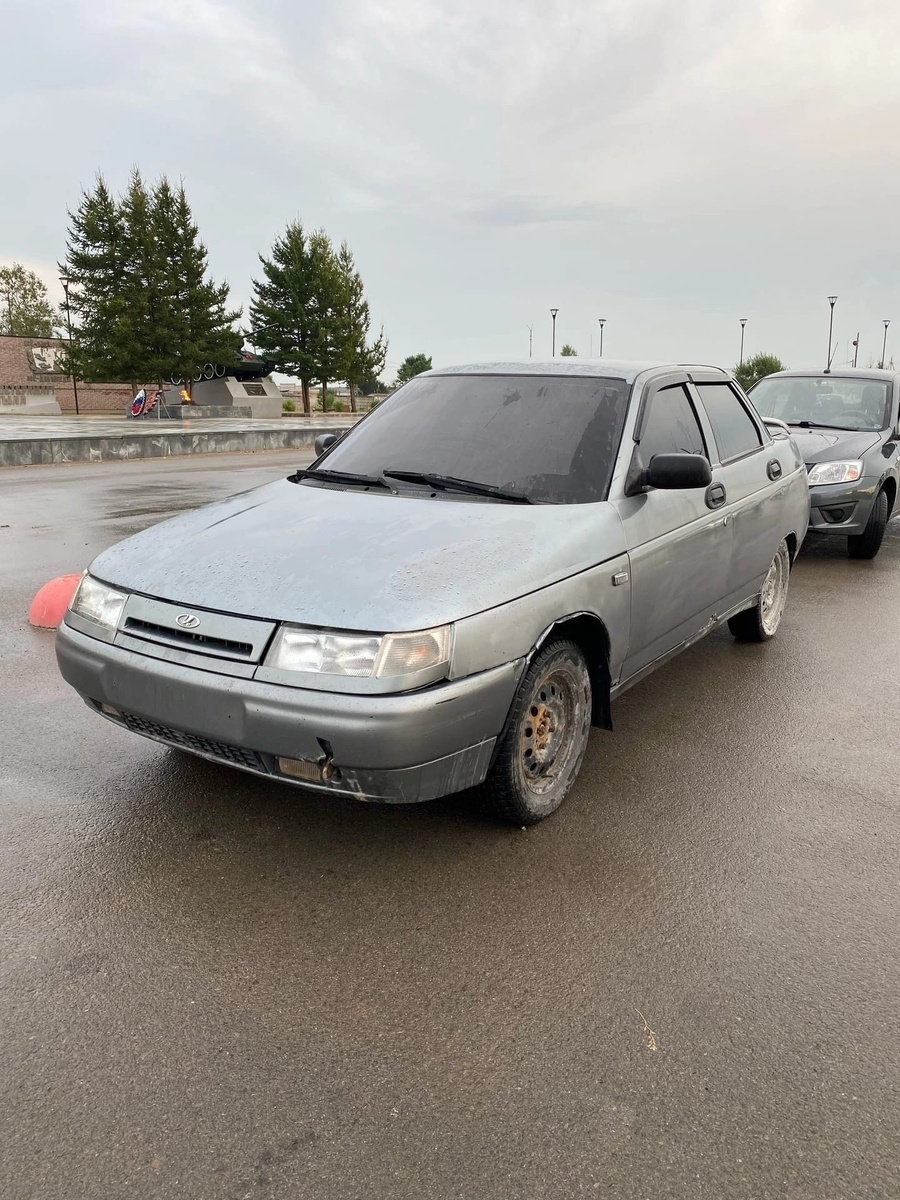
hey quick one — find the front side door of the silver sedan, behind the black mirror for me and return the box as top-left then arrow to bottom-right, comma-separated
610,376 -> 731,682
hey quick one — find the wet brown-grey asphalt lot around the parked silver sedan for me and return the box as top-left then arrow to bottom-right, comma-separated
0,455 -> 900,1200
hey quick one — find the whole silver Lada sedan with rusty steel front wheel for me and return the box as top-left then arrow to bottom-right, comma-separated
56,360 -> 809,823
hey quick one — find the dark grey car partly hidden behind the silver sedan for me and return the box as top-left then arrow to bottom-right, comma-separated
750,368 -> 900,558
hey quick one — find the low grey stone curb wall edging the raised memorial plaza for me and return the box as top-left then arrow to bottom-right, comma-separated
0,424 -> 360,467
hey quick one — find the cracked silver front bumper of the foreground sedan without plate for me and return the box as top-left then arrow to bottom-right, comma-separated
56,622 -> 523,804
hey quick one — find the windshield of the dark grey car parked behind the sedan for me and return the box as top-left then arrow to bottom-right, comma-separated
750,374 -> 890,430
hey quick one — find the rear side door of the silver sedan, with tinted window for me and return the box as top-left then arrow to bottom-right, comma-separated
692,376 -> 786,605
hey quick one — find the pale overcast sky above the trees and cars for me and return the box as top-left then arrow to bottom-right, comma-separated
0,0 -> 900,374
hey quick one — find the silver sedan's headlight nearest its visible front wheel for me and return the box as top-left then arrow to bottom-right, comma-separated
265,625 -> 451,679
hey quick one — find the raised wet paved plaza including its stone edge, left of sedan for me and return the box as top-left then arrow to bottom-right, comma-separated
0,413 -> 359,467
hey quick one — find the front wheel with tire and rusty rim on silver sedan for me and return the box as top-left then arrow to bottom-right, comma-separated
482,638 -> 592,826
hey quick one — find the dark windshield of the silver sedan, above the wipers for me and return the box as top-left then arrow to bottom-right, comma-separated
321,374 -> 628,504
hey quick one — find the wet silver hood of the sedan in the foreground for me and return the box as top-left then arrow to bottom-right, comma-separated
90,480 -> 625,632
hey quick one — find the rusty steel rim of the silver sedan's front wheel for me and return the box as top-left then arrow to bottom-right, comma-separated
518,664 -> 590,797
